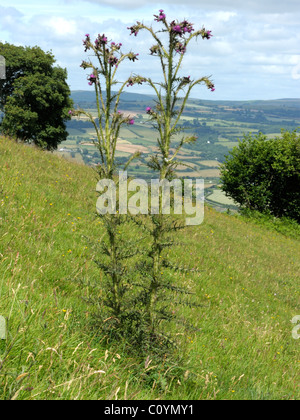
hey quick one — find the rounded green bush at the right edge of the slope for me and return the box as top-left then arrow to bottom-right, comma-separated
221,130 -> 300,222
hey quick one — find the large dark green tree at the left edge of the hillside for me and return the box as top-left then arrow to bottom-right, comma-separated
0,43 -> 73,150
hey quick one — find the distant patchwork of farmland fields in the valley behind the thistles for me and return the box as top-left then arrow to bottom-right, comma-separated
57,91 -> 300,209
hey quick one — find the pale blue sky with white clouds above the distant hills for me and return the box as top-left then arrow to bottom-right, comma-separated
0,0 -> 300,100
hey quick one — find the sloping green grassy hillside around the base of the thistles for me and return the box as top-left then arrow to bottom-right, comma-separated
0,138 -> 300,400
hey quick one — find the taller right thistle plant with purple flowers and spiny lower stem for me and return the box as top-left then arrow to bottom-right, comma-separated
128,10 -> 215,333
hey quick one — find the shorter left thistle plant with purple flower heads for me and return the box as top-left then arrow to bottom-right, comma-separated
70,34 -> 144,332
